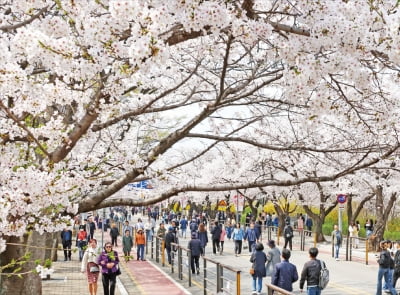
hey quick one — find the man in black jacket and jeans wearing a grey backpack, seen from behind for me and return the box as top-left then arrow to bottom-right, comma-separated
300,247 -> 321,295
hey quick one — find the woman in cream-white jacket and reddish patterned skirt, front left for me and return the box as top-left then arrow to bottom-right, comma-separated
81,239 -> 100,295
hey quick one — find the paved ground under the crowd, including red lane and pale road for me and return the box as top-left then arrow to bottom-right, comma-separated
43,216 -> 398,295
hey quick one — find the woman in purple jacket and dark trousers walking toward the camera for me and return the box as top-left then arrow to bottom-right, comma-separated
97,242 -> 119,295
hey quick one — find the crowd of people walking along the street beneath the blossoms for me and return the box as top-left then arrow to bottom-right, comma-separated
61,210 -> 400,295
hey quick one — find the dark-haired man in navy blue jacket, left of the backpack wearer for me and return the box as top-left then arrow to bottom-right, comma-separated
271,249 -> 299,292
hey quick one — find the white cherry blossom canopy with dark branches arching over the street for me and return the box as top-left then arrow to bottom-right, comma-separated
0,0 -> 400,294
